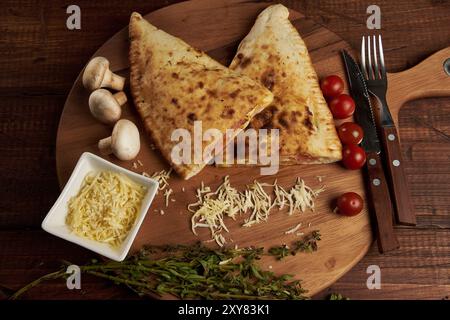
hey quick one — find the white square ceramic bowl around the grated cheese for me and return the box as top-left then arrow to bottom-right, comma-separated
42,152 -> 159,261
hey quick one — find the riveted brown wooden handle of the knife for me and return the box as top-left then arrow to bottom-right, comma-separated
366,152 -> 399,253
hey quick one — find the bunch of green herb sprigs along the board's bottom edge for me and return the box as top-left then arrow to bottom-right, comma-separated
10,232 -> 320,300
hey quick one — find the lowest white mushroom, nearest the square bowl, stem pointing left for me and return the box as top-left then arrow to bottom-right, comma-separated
98,119 -> 141,160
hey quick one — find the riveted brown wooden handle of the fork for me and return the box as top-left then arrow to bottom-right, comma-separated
381,127 -> 416,226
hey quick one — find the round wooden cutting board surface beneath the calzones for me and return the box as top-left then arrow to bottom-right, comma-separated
56,0 -> 450,295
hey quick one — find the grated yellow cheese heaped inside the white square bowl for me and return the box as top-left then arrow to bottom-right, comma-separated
66,171 -> 147,247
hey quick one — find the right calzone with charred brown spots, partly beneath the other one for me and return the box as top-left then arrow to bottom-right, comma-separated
230,5 -> 342,164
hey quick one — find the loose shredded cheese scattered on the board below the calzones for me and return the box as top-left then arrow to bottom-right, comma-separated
188,176 -> 324,246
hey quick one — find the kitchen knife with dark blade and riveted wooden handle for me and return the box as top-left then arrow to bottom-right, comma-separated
342,50 -> 399,253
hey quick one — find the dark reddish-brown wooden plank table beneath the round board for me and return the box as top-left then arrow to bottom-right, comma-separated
0,0 -> 450,299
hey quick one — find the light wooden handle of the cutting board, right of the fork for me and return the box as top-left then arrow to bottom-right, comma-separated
387,47 -> 450,125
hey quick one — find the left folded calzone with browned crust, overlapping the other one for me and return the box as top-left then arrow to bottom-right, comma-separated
129,13 -> 273,179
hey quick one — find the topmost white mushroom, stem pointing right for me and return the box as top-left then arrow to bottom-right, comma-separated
83,57 -> 125,91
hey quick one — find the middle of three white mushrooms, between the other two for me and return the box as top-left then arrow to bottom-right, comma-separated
89,89 -> 127,124
